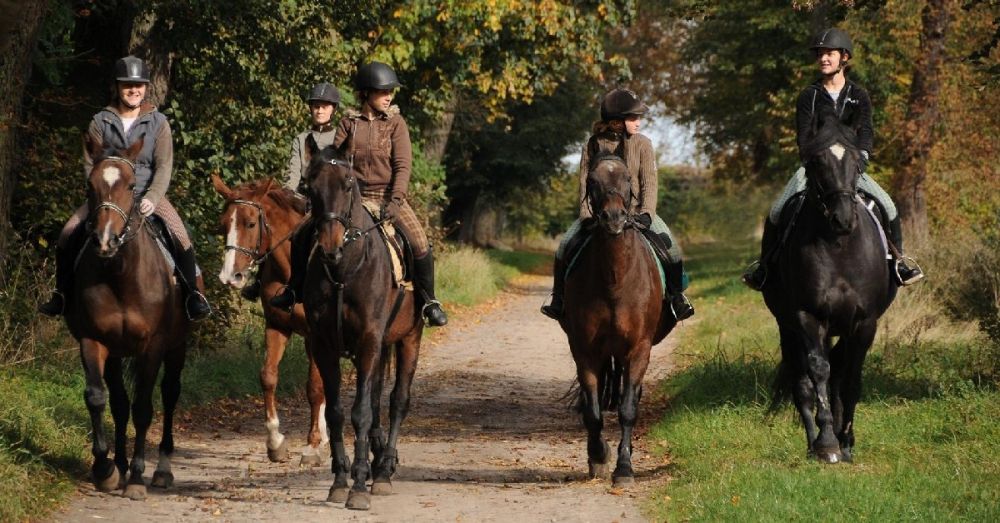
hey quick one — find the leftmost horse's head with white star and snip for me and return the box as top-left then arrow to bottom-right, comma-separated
84,134 -> 144,258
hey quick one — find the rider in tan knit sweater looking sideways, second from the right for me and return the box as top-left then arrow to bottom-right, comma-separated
542,89 -> 694,320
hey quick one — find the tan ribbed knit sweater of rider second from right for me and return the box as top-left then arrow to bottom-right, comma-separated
580,122 -> 657,218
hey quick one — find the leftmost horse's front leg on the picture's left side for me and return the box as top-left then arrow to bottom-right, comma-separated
80,338 -> 119,492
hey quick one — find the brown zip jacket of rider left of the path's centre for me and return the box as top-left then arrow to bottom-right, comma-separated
333,105 -> 413,200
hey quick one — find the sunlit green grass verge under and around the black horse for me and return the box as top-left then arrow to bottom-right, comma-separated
648,245 -> 1000,521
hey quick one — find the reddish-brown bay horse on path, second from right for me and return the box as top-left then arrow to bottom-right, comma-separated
556,151 -> 676,486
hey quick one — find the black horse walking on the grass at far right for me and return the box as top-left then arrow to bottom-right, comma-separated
763,115 -> 896,463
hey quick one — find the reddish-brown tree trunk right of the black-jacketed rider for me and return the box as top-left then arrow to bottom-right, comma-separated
892,0 -> 956,243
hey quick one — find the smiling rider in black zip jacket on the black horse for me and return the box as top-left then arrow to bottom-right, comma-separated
742,27 -> 924,290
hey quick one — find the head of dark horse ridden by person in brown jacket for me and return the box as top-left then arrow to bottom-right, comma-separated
306,136 -> 365,264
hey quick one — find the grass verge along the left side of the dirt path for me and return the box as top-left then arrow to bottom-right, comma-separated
0,248 -> 551,521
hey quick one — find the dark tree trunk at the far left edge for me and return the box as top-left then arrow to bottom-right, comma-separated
0,1 -> 48,270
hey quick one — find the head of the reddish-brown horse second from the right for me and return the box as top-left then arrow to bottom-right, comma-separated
587,153 -> 633,236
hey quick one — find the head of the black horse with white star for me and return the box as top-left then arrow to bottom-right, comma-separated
804,109 -> 862,236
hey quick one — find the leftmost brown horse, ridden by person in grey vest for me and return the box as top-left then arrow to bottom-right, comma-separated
66,135 -> 190,500
